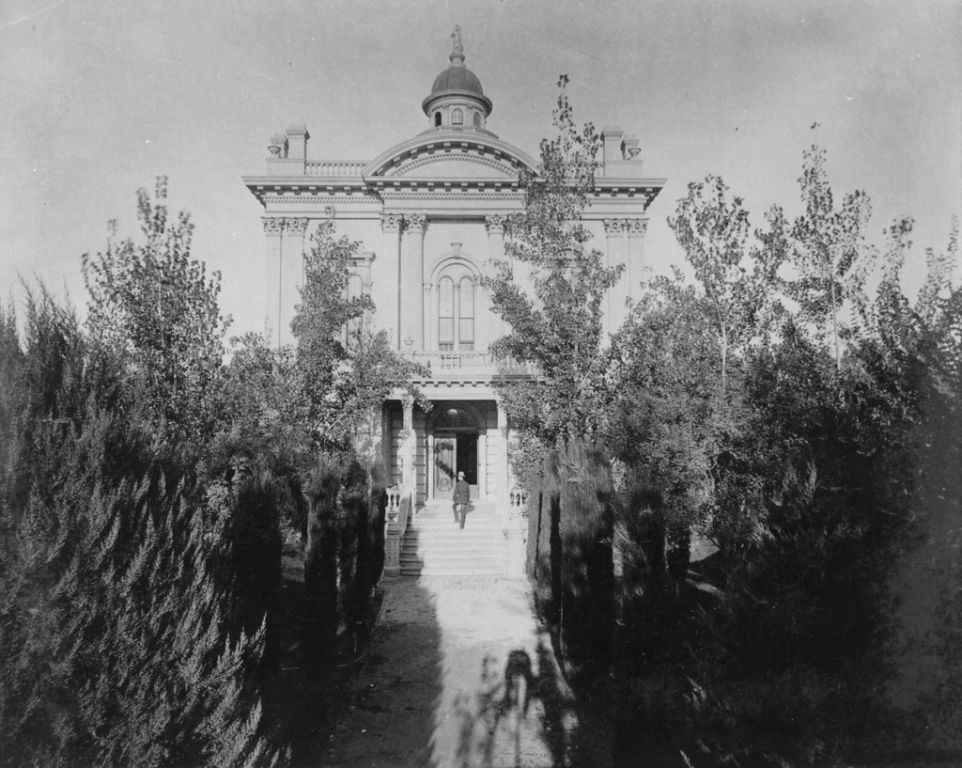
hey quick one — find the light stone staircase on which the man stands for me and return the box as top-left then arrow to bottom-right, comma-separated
401,500 -> 508,576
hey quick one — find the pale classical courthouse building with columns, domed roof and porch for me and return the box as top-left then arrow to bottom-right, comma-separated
244,30 -> 664,510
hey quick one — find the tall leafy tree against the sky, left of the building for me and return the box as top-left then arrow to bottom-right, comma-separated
83,176 -> 229,443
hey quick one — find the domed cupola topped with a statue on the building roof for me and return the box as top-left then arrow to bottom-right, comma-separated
421,27 -> 492,130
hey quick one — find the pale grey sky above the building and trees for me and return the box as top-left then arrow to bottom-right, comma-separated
0,0 -> 962,334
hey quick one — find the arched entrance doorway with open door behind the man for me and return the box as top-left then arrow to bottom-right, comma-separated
429,403 -> 481,499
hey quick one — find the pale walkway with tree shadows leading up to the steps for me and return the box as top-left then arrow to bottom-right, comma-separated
324,577 -> 576,768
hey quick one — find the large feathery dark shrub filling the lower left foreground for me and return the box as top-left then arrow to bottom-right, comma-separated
0,291 -> 280,766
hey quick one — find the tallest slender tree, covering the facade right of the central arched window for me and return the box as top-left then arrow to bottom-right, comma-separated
484,75 -> 620,445
